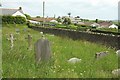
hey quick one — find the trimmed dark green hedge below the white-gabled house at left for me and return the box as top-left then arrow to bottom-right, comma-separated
2,16 -> 26,24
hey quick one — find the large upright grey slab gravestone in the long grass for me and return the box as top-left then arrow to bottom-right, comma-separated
35,38 -> 51,63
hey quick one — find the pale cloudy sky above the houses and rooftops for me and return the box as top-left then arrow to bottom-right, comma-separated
1,0 -> 120,20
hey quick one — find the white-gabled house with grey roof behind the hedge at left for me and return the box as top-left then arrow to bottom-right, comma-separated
0,7 -> 26,18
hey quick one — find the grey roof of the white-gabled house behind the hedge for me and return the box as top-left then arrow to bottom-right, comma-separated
0,8 -> 24,15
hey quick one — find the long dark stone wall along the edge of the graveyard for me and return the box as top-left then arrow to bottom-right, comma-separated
30,27 -> 120,49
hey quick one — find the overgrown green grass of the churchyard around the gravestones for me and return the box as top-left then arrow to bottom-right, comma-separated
2,24 -> 118,78
